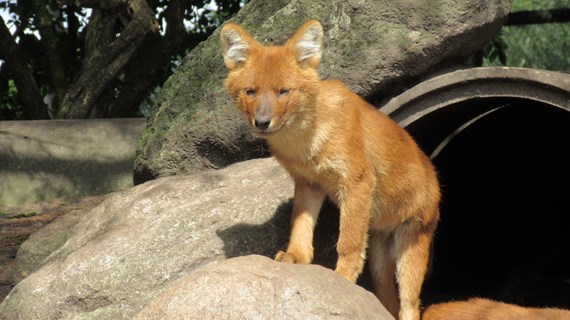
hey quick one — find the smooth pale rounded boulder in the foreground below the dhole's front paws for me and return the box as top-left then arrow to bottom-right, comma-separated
134,256 -> 394,320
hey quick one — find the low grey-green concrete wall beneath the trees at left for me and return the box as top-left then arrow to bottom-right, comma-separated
0,118 -> 146,206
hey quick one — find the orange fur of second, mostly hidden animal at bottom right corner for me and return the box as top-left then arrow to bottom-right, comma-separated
422,298 -> 570,320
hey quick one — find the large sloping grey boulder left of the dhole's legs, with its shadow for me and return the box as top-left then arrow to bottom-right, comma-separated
0,158 -> 336,320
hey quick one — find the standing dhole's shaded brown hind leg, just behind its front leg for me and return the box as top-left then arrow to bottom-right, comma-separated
368,232 -> 400,319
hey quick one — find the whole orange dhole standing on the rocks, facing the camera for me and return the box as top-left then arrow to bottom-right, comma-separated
221,20 -> 440,320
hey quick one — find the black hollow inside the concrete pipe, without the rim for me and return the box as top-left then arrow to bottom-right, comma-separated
406,98 -> 570,309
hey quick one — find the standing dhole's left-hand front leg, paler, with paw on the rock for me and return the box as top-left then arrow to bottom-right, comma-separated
275,181 -> 325,264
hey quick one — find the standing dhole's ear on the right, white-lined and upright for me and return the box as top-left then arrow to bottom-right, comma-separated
287,20 -> 324,68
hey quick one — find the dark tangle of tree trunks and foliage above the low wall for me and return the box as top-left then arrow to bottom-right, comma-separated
0,0 -> 243,120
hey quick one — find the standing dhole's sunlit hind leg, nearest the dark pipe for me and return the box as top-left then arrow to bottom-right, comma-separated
394,218 -> 437,320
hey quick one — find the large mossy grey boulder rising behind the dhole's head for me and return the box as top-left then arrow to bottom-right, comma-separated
135,0 -> 511,183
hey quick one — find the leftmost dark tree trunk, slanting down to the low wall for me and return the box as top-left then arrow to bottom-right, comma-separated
0,16 -> 49,119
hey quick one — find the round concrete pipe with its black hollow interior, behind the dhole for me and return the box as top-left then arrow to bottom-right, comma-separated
382,68 -> 570,309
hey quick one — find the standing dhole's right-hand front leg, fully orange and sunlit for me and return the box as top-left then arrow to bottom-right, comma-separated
335,176 -> 374,283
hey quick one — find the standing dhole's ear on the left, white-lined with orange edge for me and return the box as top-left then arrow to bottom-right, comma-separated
220,23 -> 256,71
